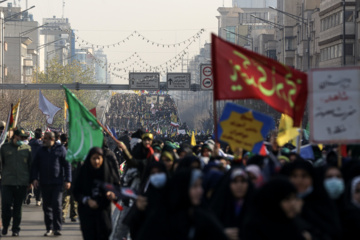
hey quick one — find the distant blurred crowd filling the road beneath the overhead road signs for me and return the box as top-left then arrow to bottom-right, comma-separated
105,93 -> 180,135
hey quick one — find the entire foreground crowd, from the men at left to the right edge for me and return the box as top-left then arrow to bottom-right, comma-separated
0,117 -> 360,240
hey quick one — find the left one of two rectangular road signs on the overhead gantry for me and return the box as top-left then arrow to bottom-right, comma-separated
129,72 -> 160,90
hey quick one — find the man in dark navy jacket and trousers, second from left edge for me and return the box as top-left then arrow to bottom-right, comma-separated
31,132 -> 71,236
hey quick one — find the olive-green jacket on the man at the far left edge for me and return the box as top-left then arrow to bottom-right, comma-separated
0,142 -> 32,186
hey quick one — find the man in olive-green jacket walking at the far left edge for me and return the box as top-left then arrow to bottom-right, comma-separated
0,129 -> 31,236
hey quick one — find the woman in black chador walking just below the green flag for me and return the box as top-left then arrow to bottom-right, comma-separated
74,147 -> 118,240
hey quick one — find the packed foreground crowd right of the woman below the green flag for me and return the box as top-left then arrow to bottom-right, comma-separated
104,130 -> 360,240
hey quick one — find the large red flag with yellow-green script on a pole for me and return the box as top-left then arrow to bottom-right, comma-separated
211,34 -> 307,127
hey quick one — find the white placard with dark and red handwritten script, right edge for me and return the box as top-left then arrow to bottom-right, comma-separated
309,67 -> 360,144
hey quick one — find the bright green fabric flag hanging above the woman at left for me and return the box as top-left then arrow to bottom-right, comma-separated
64,86 -> 104,163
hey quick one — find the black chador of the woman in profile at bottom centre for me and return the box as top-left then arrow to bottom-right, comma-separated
136,169 -> 227,240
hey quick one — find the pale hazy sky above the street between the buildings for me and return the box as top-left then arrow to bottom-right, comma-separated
1,0 -> 231,83
